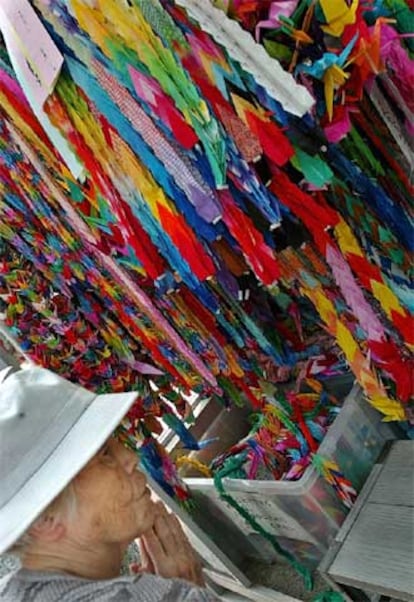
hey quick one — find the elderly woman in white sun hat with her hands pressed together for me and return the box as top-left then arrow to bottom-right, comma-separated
0,368 -> 216,602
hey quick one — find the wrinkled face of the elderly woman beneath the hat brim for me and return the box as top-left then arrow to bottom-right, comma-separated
73,438 -> 156,544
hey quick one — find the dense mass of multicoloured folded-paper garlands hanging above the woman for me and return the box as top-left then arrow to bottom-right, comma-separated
0,0 -> 413,502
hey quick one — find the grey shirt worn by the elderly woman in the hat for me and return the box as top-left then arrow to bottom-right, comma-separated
0,569 -> 218,602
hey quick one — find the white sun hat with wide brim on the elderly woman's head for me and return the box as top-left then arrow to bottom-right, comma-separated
0,367 -> 138,554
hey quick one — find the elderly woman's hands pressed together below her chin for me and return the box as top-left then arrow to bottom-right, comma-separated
138,502 -> 205,587
